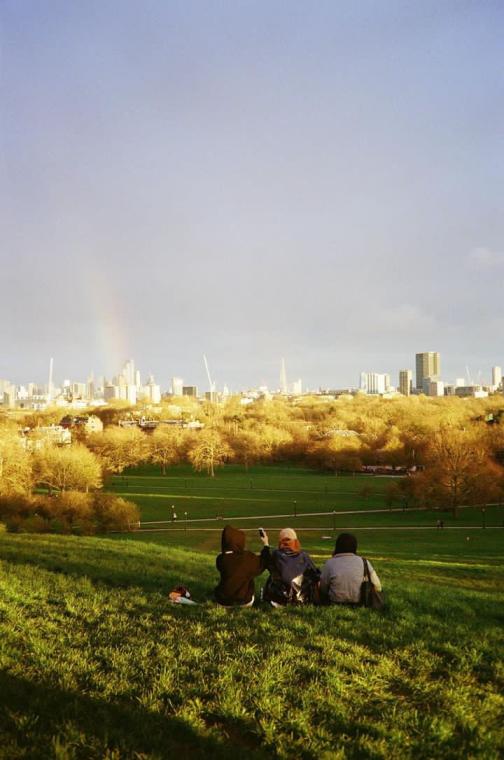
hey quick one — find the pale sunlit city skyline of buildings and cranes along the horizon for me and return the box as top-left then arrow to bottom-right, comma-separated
0,351 -> 504,410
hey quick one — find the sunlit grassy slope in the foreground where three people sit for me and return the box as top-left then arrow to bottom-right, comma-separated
0,530 -> 504,760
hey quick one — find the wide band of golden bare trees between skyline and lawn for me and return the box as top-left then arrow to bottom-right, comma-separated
0,395 -> 504,511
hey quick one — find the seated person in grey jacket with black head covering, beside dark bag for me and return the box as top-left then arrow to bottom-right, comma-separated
320,533 -> 382,604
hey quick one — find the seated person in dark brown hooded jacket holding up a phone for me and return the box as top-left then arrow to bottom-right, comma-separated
214,525 -> 269,607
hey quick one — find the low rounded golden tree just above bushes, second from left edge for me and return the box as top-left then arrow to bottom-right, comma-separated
33,444 -> 101,491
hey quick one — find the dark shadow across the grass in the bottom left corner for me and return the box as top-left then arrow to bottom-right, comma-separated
0,671 -> 271,760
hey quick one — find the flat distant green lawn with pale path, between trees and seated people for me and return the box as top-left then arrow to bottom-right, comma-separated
107,466 -> 504,529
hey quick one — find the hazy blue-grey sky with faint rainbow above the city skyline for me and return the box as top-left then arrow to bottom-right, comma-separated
0,0 -> 504,388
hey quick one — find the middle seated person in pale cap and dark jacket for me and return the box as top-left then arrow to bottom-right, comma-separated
264,528 -> 320,606
